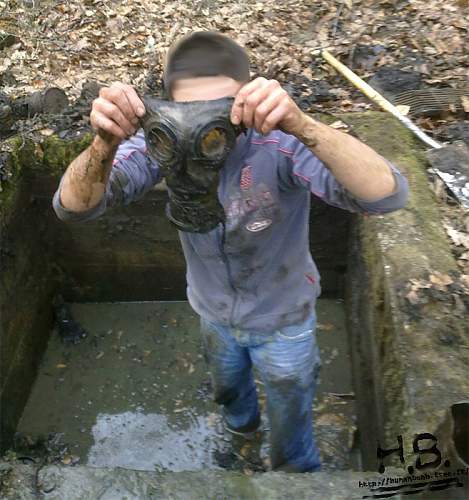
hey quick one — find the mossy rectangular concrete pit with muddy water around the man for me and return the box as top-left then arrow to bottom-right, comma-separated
0,113 -> 469,498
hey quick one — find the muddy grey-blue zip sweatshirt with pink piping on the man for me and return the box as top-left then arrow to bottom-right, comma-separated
53,129 -> 408,332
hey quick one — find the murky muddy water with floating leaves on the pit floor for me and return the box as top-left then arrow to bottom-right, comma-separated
18,300 -> 357,471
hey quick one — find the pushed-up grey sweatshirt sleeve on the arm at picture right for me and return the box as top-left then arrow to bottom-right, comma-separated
279,134 -> 409,215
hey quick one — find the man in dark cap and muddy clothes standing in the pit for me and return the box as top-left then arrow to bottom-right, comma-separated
53,32 -> 408,472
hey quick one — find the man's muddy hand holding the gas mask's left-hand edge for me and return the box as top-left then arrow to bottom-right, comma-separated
90,83 -> 145,146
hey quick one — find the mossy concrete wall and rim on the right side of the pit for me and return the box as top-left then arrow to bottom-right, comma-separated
346,113 -> 469,465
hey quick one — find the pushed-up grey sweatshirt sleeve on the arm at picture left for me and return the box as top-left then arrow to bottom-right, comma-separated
52,129 -> 162,222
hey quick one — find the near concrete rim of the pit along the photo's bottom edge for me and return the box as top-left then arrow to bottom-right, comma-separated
0,463 -> 440,500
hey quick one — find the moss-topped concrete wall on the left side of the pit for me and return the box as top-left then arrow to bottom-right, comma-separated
0,134 -> 91,448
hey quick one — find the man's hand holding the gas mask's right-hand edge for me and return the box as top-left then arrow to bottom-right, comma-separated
231,77 -> 304,135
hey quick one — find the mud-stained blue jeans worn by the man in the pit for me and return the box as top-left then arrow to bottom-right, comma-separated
197,314 -> 321,472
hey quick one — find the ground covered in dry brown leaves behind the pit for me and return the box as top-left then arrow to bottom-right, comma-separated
0,0 -> 469,286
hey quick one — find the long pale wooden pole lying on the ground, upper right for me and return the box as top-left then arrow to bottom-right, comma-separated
321,50 -> 443,149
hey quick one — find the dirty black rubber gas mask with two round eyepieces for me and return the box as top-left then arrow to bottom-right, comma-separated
142,96 -> 245,233
